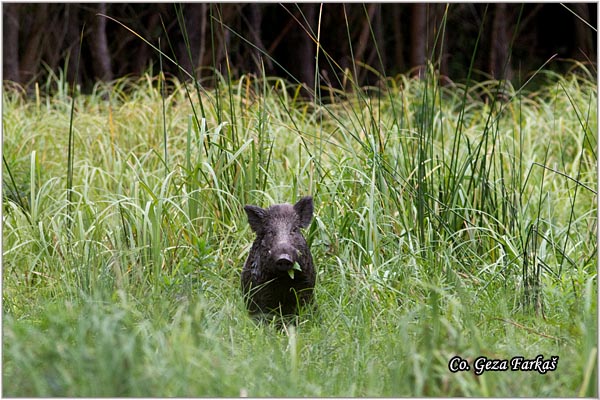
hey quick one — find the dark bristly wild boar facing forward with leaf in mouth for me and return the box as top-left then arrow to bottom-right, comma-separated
242,197 -> 315,315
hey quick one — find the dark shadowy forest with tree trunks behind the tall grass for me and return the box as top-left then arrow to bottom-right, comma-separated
2,3 -> 597,89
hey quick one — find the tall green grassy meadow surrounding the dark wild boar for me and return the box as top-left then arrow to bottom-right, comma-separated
2,65 -> 598,397
